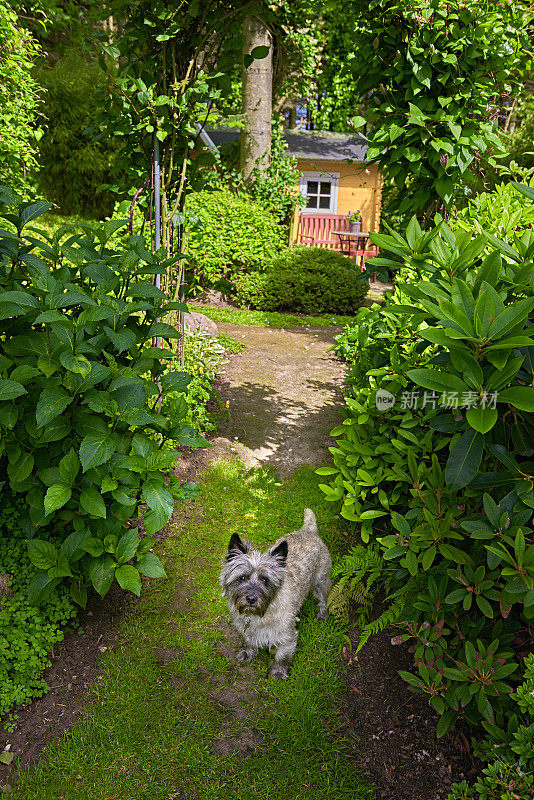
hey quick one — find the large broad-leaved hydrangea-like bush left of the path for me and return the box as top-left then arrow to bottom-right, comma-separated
0,189 -> 204,605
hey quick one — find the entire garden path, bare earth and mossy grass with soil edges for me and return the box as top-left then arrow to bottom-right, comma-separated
0,323 -> 468,800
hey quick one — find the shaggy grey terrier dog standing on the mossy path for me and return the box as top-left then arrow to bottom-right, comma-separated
221,508 -> 332,680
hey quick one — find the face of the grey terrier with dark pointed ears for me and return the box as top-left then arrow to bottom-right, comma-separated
221,533 -> 287,617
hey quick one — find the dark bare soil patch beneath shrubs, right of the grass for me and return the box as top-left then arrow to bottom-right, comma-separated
343,630 -> 475,800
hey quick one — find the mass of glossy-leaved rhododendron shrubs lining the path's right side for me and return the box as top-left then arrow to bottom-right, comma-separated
321,180 -> 534,797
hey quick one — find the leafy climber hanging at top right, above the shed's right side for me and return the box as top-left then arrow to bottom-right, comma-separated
349,0 -> 531,215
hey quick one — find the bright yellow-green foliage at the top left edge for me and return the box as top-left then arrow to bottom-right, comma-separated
0,3 -> 40,190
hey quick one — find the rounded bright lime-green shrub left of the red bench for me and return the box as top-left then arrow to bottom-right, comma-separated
187,189 -> 287,284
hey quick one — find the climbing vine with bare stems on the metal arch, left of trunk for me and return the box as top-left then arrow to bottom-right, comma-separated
96,0 -> 254,276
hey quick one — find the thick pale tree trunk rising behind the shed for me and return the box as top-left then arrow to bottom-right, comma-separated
241,17 -> 273,184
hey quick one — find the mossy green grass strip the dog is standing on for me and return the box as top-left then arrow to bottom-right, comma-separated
10,460 -> 373,800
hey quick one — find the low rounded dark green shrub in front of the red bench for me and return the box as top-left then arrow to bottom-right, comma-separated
235,246 -> 369,314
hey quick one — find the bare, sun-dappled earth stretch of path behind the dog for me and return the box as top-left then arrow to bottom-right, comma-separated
195,322 -> 345,477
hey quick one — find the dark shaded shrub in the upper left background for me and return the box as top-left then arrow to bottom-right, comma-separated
34,49 -> 122,218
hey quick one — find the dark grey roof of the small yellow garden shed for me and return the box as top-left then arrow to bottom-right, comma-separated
207,128 -> 367,161
